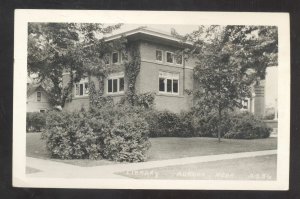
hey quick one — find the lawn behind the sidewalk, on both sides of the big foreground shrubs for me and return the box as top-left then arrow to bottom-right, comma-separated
26,133 -> 277,166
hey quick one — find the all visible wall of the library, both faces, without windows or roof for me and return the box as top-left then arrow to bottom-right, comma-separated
63,41 -> 195,112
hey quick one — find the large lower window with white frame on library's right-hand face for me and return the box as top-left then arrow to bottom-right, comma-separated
159,72 -> 179,95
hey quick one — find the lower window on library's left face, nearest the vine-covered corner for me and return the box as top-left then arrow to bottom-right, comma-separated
107,73 -> 125,94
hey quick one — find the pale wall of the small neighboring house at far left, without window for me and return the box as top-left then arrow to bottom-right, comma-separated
26,90 -> 50,112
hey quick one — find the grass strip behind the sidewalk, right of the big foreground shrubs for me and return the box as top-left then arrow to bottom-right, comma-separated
148,137 -> 277,161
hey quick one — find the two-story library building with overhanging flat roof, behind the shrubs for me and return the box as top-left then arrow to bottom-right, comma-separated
63,28 -> 264,116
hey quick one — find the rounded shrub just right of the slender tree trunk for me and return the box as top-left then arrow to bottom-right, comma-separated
224,112 -> 272,139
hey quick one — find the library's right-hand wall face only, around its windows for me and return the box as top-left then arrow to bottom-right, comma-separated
137,42 -> 193,112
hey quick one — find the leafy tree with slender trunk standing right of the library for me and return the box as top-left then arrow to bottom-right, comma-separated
185,26 -> 278,141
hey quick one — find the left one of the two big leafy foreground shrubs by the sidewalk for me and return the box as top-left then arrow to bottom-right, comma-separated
42,111 -> 101,159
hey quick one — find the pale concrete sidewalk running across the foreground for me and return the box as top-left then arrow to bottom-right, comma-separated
26,150 -> 277,178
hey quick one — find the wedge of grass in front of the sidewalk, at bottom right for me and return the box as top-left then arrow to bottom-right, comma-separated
117,155 -> 277,180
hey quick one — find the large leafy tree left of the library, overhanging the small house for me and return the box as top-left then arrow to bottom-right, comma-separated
27,23 -> 121,106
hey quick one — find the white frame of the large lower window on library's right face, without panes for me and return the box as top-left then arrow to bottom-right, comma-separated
158,71 -> 180,95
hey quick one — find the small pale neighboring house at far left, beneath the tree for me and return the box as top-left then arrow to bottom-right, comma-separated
26,83 -> 51,112
